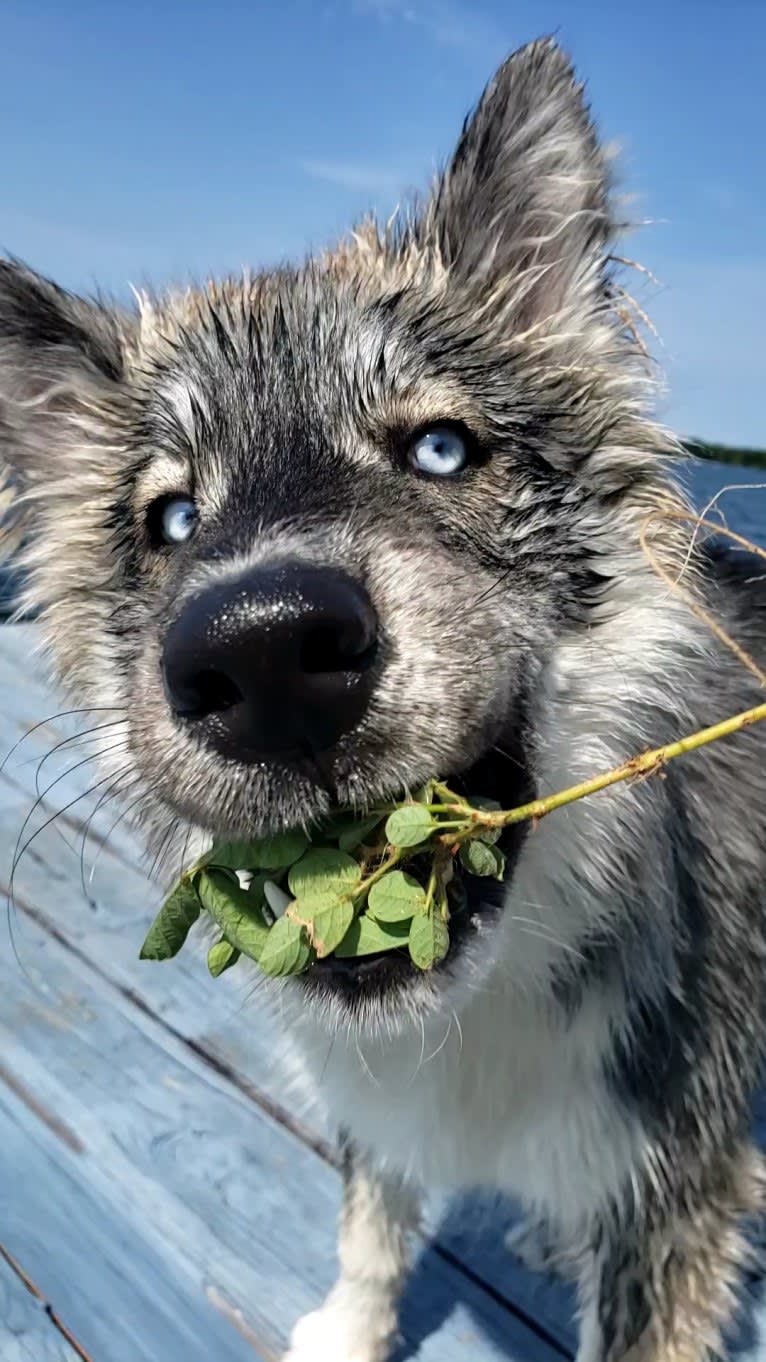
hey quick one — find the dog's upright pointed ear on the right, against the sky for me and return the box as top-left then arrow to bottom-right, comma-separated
421,39 -> 611,323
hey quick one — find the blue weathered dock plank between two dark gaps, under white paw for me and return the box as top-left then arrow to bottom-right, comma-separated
0,866 -> 557,1362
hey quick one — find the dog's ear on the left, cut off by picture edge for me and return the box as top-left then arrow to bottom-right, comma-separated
0,260 -> 128,488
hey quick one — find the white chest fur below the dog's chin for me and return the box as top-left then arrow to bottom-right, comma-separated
283,958 -> 641,1230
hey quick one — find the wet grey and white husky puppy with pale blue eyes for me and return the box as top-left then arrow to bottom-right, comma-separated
0,42 -> 766,1362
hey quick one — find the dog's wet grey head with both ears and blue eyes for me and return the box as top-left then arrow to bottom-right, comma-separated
0,44 -> 667,1024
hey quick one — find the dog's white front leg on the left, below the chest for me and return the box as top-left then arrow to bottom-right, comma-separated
285,1137 -> 420,1362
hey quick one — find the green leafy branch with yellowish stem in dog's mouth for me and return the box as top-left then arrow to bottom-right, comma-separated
140,704 -> 766,977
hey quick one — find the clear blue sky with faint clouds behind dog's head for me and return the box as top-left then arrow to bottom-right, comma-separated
0,0 -> 766,445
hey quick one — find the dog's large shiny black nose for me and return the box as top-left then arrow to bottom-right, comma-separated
162,564 -> 378,761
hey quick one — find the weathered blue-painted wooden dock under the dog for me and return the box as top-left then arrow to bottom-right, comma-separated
0,624 -> 766,1362
